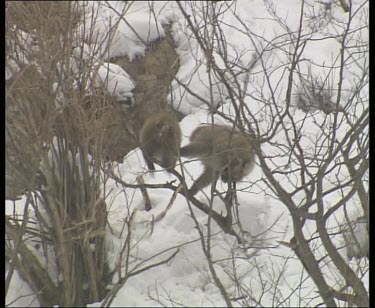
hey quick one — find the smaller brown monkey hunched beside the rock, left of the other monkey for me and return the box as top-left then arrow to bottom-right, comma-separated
139,112 -> 181,170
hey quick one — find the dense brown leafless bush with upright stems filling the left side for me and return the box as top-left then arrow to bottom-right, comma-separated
6,2 -> 110,306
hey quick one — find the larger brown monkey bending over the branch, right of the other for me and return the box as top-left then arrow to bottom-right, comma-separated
180,125 -> 255,195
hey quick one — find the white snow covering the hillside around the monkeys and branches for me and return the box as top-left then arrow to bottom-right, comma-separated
6,0 -> 368,307
